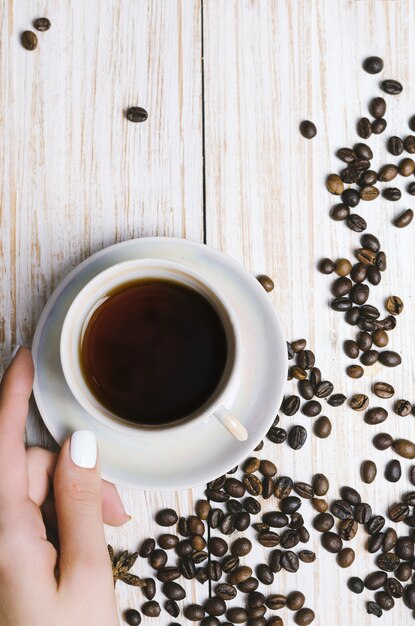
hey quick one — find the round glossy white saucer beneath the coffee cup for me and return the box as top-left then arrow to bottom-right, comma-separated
32,237 -> 287,491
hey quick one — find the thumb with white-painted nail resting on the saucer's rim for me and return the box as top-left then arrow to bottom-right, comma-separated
54,430 -> 112,586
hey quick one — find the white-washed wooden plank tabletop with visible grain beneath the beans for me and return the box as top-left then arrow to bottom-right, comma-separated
0,0 -> 415,626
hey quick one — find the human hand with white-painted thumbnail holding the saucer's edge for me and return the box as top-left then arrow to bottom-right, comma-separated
0,348 -> 130,626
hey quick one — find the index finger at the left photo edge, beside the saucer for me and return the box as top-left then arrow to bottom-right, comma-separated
0,348 -> 34,514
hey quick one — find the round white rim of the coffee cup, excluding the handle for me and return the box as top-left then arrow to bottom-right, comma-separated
59,257 -> 240,438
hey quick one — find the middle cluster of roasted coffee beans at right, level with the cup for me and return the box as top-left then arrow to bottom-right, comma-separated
319,234 -> 403,379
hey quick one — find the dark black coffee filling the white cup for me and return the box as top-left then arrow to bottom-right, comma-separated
81,280 -> 228,425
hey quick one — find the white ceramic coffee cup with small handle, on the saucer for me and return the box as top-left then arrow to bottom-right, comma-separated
60,258 -> 248,441
